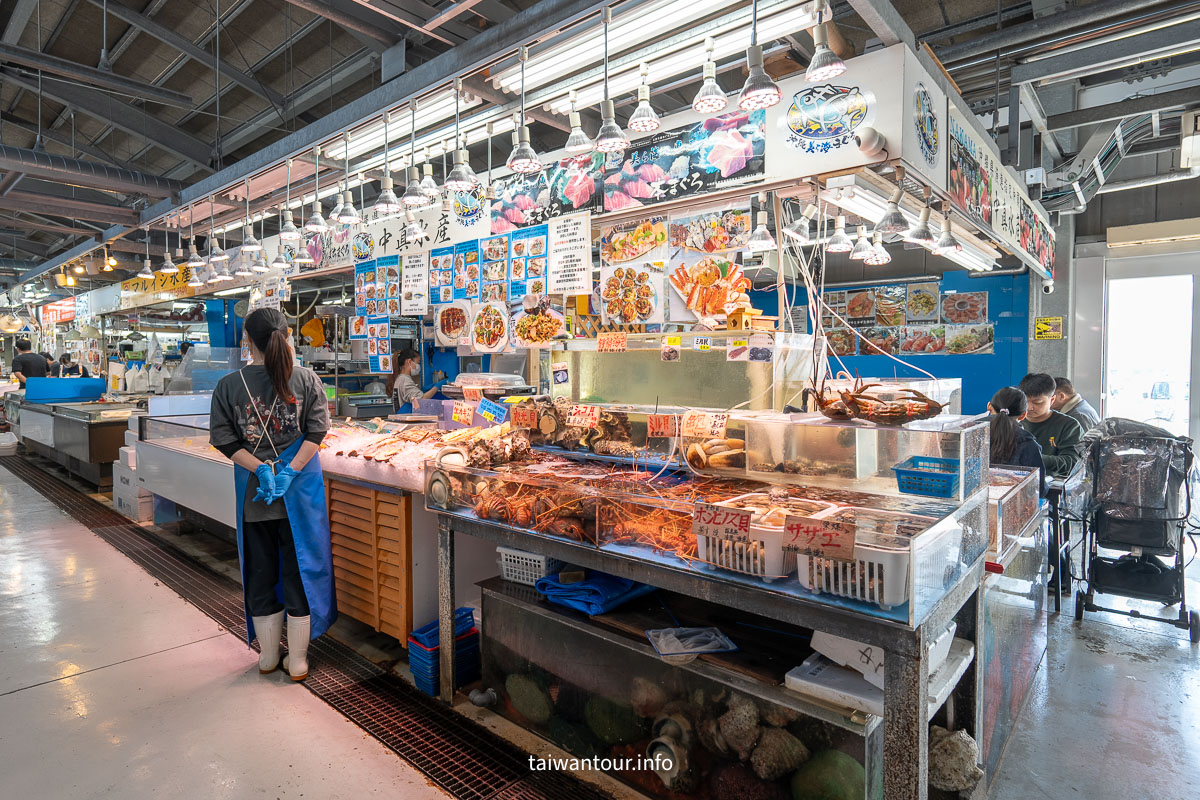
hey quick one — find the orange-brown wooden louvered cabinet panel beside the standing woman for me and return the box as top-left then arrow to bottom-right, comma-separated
325,476 -> 413,644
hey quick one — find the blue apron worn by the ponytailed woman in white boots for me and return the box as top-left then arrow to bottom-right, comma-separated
233,438 -> 337,644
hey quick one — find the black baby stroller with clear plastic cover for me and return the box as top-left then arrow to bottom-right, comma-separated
1075,419 -> 1200,642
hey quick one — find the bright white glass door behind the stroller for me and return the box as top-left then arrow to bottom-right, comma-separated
1100,271 -> 1196,438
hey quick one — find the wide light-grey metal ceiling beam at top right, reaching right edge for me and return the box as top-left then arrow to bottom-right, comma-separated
1012,19 -> 1200,84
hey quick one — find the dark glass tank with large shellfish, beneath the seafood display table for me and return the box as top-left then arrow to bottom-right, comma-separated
481,579 -> 883,800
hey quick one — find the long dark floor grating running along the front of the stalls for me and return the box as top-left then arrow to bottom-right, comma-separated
0,456 -> 610,800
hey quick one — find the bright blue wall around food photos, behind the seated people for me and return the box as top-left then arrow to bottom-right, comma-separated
751,270 -> 1030,414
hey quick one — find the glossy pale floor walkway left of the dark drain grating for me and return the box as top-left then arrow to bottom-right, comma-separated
0,469 -> 448,800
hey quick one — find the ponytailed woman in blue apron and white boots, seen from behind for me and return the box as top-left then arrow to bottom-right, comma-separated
209,308 -> 337,680
